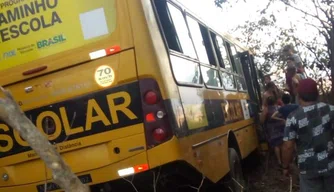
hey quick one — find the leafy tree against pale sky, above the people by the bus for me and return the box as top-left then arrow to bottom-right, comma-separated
215,0 -> 334,101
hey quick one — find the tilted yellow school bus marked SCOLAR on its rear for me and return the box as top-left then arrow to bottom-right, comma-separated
0,0 -> 260,192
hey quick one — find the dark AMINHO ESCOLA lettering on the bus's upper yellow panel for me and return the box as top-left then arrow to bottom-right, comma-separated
0,0 -> 62,42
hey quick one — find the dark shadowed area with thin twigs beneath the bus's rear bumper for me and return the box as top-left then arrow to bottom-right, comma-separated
90,161 -> 208,192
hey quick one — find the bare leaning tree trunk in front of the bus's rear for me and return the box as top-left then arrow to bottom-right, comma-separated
0,87 -> 90,192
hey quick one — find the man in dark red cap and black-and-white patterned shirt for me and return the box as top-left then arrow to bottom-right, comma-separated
282,79 -> 334,192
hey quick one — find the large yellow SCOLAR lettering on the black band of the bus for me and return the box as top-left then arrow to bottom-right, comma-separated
0,91 -> 138,153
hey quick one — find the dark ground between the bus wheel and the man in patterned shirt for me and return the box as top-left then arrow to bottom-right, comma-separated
244,154 -> 299,192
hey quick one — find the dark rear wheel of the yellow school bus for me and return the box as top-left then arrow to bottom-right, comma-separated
228,148 -> 246,192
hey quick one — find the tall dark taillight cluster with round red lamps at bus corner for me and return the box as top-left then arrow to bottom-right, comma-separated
139,79 -> 173,148
